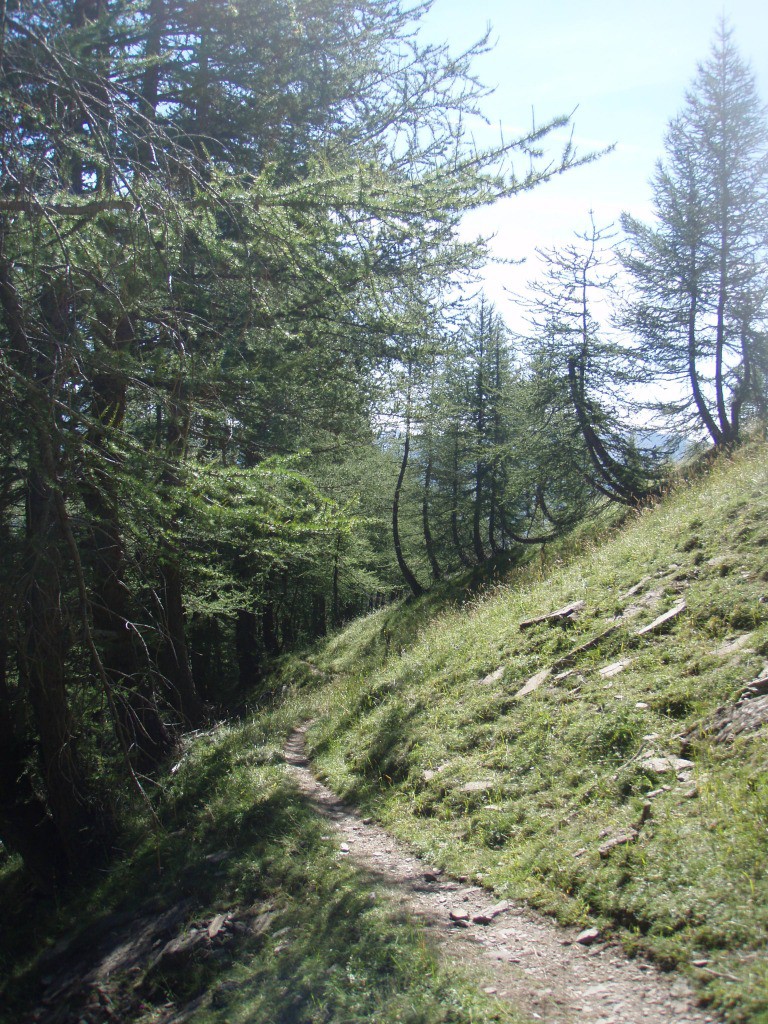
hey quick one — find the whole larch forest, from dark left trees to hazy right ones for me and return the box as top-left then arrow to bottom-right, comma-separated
0,0 -> 768,894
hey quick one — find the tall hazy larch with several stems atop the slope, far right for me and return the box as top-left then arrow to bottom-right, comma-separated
623,24 -> 768,445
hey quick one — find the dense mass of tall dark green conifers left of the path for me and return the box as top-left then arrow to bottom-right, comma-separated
0,0 -> 573,888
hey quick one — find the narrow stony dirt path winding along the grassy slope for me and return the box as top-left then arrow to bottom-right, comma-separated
286,728 -> 718,1024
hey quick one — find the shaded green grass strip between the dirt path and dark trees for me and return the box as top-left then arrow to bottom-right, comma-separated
0,711 -> 519,1024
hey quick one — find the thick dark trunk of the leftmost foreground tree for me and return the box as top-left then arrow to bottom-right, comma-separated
0,260 -> 112,878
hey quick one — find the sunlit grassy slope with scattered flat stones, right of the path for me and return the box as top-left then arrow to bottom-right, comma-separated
285,445 -> 768,1021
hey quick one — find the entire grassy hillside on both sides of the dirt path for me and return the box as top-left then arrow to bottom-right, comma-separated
0,444 -> 768,1024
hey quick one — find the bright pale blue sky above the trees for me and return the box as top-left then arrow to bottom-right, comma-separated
422,0 -> 768,330
